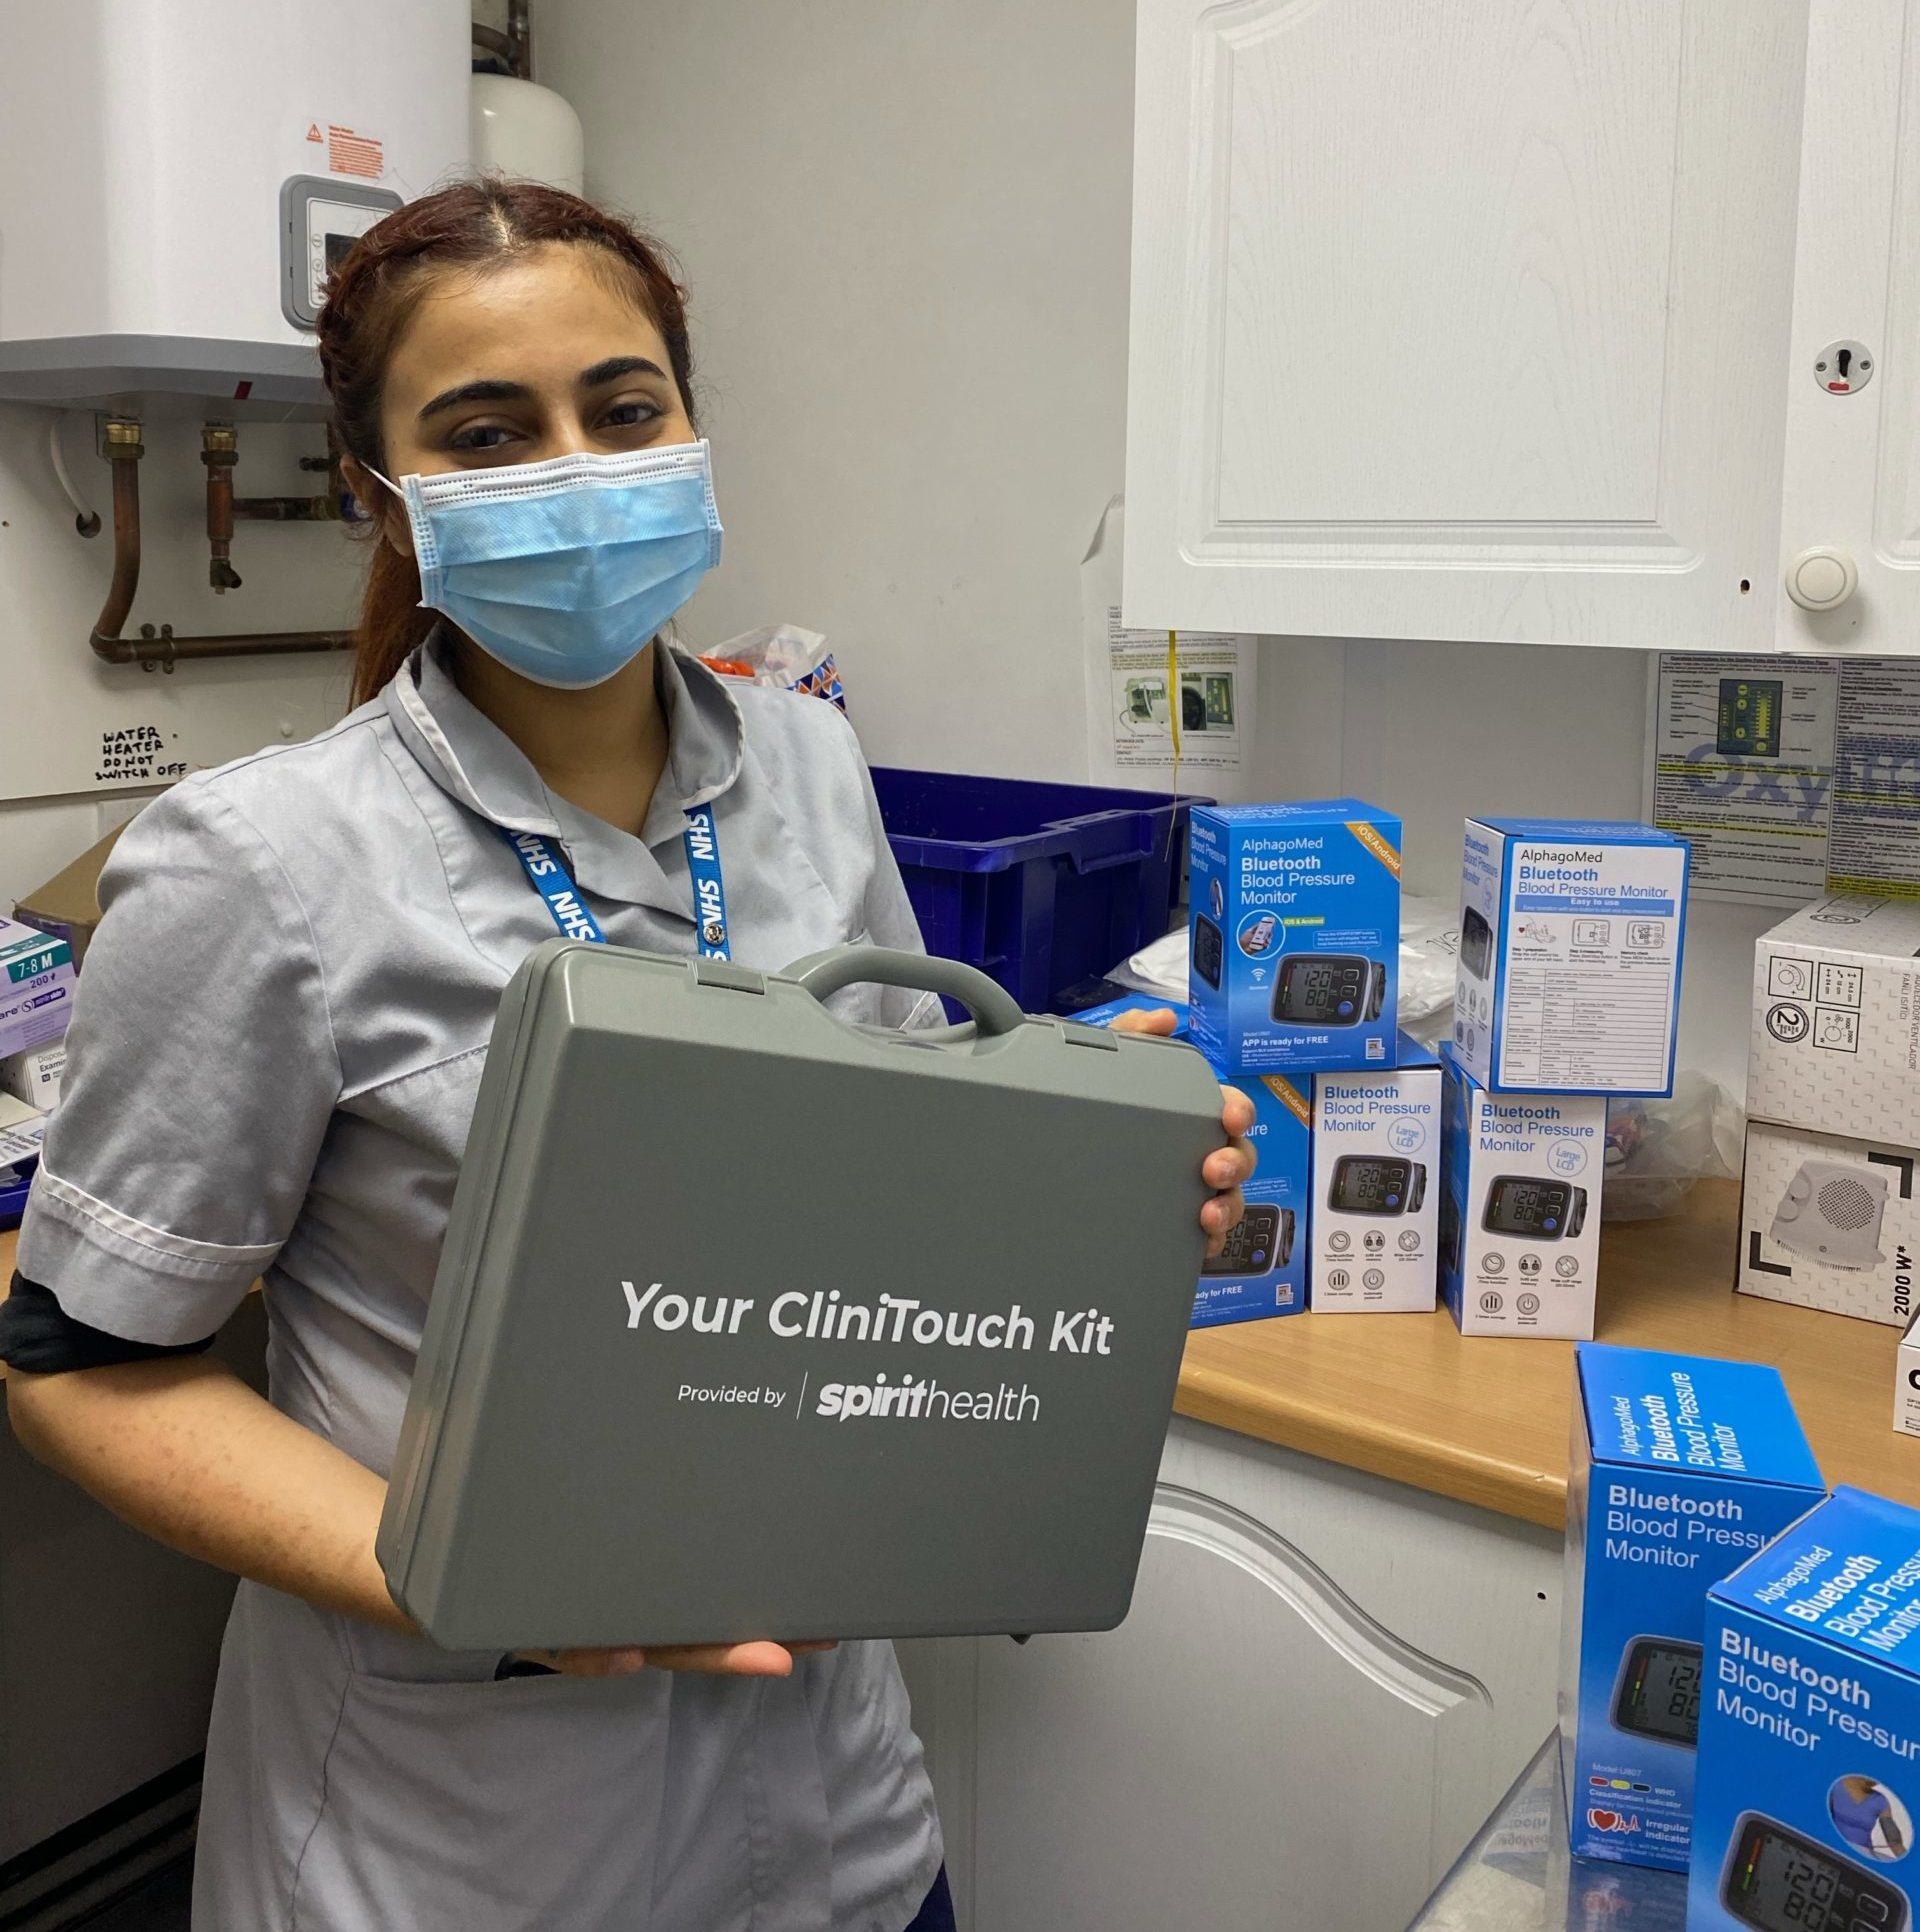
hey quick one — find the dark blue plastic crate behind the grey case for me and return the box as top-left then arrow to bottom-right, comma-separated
873,767 -> 1211,1012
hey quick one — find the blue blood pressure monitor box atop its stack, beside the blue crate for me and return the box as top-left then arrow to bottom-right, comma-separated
1188,798 -> 1400,1074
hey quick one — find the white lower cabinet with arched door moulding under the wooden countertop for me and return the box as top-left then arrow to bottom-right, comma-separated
900,1422 -> 1561,1932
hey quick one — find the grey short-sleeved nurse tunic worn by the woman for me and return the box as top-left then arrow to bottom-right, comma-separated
19,645 -> 941,1932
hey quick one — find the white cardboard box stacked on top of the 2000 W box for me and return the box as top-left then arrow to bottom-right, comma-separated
1746,895 -> 1920,1148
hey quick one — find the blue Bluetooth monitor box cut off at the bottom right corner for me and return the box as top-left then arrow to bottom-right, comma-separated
1686,1490 -> 1920,1932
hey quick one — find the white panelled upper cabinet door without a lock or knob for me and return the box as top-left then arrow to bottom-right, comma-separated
1124,0 -> 1806,649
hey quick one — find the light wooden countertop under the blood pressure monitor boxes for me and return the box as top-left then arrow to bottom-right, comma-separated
0,1180 -> 1920,1528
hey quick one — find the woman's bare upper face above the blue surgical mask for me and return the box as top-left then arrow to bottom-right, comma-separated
363,242 -> 695,551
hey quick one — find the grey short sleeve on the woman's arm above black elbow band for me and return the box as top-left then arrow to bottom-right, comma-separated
19,781 -> 342,1345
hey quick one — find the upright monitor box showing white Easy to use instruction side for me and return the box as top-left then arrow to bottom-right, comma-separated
1453,819 -> 1686,1097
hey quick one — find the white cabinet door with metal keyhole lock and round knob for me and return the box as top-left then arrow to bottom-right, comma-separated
1773,0 -> 1920,653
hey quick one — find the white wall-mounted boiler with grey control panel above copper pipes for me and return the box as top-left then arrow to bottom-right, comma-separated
0,0 -> 469,410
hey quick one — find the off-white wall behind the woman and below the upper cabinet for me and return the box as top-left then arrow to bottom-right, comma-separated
537,0 -> 1771,1088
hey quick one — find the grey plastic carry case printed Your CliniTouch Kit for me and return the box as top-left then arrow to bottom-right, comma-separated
379,939 -> 1221,1650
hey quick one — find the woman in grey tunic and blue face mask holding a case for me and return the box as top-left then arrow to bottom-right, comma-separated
0,184 -> 1252,1932
